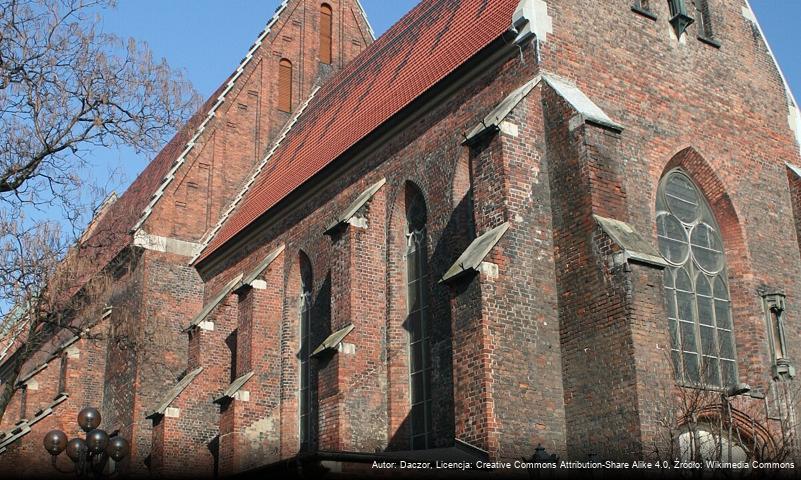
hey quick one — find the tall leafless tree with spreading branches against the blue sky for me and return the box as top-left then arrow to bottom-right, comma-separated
0,0 -> 199,419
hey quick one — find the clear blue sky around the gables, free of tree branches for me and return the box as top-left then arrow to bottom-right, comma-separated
96,0 -> 801,192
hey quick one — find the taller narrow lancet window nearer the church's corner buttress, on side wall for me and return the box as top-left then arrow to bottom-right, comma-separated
406,186 -> 432,449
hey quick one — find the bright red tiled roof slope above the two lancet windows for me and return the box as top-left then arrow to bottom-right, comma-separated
198,0 -> 519,261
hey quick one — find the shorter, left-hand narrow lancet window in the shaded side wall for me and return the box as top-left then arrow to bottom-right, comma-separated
298,253 -> 314,450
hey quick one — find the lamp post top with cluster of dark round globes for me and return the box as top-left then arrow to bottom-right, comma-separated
42,407 -> 130,477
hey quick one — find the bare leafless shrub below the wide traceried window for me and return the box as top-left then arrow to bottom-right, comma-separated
651,359 -> 801,478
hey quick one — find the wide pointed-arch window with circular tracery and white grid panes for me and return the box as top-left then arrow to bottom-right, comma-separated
656,169 -> 737,387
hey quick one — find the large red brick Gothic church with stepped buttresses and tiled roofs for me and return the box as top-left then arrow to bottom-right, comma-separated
0,0 -> 801,477
